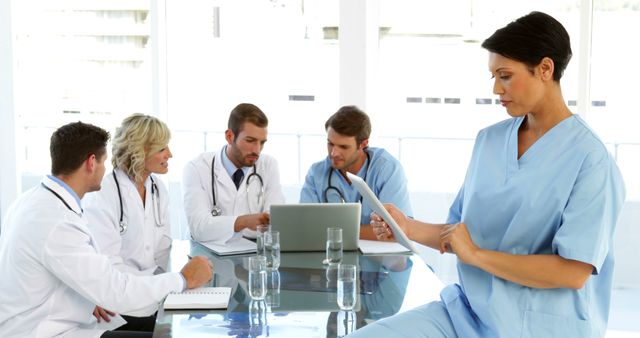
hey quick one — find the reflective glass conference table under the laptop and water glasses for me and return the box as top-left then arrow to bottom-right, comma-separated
153,241 -> 443,338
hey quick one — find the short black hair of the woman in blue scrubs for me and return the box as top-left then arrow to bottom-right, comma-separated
482,12 -> 572,82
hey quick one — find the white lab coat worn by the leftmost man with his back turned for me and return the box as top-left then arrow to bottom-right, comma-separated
0,177 -> 184,338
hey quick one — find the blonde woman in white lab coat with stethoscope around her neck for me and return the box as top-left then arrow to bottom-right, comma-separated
83,114 -> 172,321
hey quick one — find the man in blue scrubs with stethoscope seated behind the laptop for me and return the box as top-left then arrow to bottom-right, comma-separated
300,106 -> 412,239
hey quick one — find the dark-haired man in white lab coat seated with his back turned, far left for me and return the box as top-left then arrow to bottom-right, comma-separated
0,122 -> 212,338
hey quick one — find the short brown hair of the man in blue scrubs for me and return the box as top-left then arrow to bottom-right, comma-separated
324,106 -> 371,145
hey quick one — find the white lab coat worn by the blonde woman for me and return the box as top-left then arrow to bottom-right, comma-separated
82,169 -> 171,275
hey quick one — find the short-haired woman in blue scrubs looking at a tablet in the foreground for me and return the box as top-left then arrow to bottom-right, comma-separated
354,12 -> 625,338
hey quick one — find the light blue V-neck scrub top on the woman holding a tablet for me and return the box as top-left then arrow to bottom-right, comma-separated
441,115 -> 625,337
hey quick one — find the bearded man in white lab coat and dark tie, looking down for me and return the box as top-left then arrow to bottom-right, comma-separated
182,103 -> 284,244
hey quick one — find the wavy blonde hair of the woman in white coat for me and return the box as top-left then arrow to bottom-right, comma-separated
111,114 -> 171,182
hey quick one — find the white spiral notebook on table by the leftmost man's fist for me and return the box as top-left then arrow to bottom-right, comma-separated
164,287 -> 231,310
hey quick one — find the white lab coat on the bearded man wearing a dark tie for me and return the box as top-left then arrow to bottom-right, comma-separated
182,147 -> 284,243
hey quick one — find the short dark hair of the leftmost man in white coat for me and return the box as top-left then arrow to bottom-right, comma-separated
49,122 -> 109,175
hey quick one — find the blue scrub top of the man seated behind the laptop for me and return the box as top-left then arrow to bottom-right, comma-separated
300,147 -> 413,224
